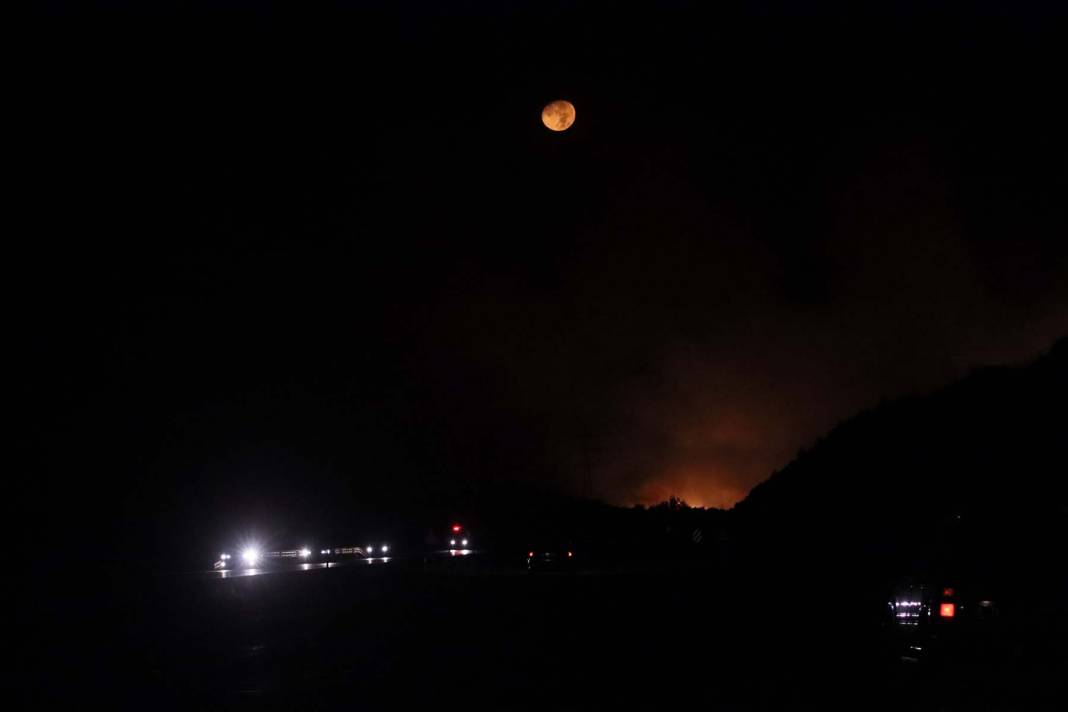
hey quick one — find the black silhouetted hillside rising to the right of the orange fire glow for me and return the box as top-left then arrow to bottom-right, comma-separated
732,338 -> 1068,597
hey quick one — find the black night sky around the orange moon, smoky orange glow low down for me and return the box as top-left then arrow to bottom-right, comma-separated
16,2 -> 1068,546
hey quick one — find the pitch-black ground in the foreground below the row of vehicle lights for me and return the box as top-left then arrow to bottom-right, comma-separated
31,563 -> 1065,710
